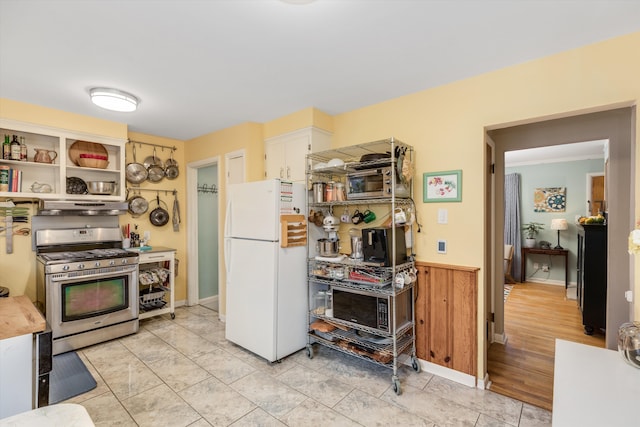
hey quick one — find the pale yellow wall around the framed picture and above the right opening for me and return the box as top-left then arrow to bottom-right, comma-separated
0,32 -> 640,378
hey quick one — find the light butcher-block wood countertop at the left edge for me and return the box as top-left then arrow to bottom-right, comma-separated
0,295 -> 47,339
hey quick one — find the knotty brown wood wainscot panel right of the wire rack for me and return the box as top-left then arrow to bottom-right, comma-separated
415,262 -> 478,376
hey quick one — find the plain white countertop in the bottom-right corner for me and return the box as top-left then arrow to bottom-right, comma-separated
552,339 -> 640,427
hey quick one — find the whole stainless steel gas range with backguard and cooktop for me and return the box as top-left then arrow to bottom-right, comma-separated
34,229 -> 139,355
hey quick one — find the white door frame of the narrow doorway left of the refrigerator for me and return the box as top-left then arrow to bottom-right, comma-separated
187,156 -> 224,306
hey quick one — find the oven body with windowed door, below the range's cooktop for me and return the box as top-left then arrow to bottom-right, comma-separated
36,258 -> 139,355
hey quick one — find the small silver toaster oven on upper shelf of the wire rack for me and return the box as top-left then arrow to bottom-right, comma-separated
347,166 -> 411,200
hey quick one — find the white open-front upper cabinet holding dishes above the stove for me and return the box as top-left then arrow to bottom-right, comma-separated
0,119 -> 127,201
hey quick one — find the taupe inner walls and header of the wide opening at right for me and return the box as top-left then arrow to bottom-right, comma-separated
485,107 -> 635,408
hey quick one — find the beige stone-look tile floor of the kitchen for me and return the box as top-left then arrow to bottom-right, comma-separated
67,306 -> 551,427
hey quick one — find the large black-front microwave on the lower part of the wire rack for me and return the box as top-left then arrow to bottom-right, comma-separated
332,286 -> 413,333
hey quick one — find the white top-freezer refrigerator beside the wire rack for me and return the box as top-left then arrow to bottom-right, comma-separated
224,179 -> 307,362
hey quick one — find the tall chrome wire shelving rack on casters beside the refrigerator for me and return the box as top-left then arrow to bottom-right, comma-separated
307,138 -> 420,394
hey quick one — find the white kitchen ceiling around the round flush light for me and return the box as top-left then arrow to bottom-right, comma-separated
0,0 -> 640,139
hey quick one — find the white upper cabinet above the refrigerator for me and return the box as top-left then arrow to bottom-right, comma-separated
264,127 -> 331,182
